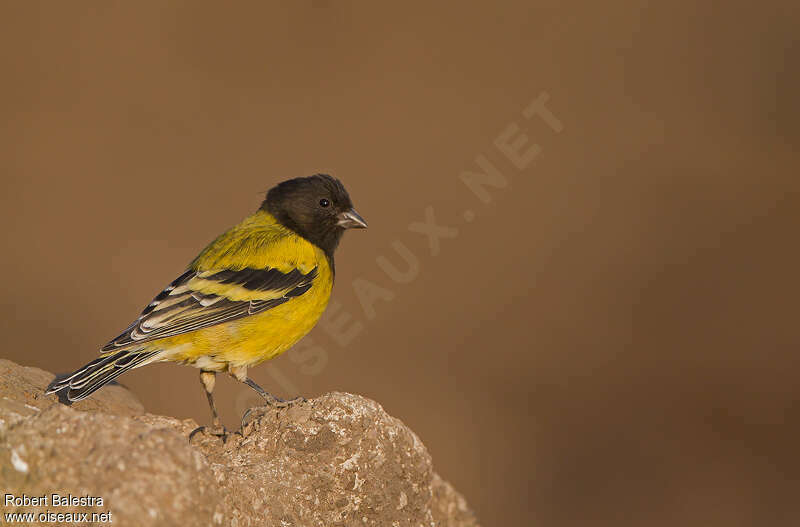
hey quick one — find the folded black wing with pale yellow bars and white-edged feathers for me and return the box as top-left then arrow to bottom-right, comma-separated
102,267 -> 317,351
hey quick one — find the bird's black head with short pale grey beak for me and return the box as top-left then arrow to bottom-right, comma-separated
261,174 -> 367,260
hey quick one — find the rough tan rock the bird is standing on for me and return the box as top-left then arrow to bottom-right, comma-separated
0,360 -> 478,527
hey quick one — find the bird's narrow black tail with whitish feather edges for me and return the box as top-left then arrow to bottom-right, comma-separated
46,349 -> 160,401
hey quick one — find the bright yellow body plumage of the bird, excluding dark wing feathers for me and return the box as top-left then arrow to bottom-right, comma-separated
139,211 -> 333,372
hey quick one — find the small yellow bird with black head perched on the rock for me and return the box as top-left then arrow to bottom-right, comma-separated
47,174 -> 367,430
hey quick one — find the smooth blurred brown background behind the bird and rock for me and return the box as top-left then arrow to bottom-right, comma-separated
0,1 -> 800,526
